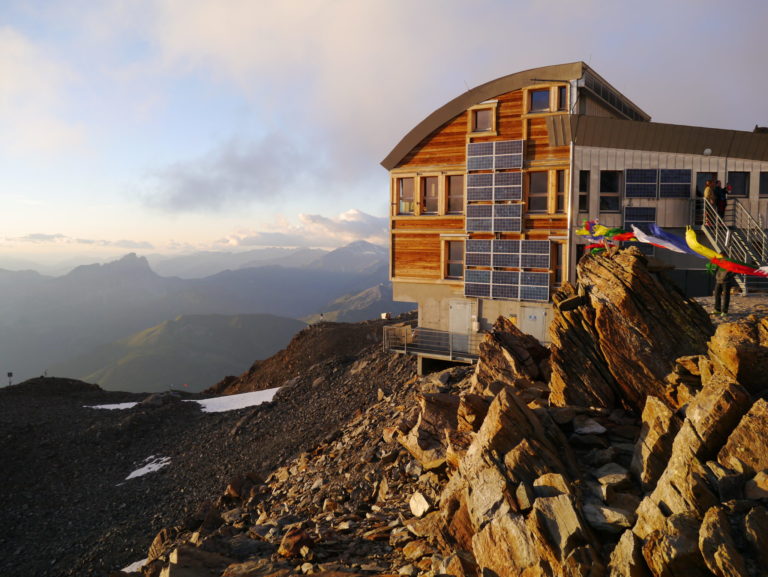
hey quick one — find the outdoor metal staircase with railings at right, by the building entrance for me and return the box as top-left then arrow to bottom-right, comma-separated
695,198 -> 768,294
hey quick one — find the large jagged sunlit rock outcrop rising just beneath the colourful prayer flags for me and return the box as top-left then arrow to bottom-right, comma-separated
550,248 -> 714,412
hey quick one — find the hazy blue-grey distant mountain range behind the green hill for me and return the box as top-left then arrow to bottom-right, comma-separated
0,242 -> 412,384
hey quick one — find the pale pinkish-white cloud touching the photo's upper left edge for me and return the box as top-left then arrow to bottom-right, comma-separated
0,26 -> 86,154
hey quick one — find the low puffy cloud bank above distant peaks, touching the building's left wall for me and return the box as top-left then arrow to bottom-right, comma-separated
219,209 -> 388,248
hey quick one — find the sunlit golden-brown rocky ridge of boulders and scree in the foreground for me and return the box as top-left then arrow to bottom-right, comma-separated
115,249 -> 768,577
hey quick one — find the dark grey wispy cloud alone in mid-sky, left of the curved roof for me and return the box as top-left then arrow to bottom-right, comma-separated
143,134 -> 322,212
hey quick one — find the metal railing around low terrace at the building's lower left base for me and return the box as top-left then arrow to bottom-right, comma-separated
384,323 -> 483,362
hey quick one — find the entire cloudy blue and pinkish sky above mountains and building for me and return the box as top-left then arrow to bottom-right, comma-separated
0,0 -> 768,268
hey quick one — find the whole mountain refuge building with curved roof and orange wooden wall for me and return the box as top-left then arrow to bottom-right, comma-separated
381,62 -> 768,369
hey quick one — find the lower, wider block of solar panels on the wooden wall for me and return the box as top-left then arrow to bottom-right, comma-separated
464,239 -> 550,302
